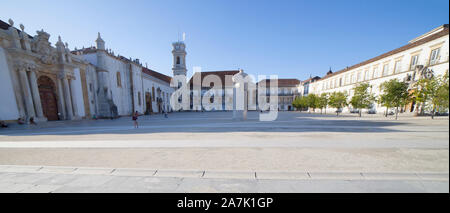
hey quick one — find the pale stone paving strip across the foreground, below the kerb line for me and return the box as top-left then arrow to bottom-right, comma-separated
0,165 -> 449,193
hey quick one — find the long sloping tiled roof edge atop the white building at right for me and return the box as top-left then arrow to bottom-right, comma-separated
320,24 -> 449,80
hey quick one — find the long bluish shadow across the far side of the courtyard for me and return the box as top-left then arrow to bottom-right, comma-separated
0,111 -> 426,136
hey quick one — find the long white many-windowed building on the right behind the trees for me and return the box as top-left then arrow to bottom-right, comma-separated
309,24 -> 449,113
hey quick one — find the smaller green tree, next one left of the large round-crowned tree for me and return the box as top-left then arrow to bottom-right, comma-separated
350,83 -> 375,117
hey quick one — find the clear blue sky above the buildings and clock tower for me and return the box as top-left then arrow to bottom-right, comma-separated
0,0 -> 449,80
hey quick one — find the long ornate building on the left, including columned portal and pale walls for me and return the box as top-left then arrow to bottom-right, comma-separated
0,20 -> 174,121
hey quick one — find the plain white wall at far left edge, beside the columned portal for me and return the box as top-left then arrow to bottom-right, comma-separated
0,47 -> 19,120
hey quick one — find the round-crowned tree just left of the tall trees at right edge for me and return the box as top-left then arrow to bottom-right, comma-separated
380,79 -> 410,120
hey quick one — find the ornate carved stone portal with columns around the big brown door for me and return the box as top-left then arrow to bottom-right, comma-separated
0,20 -> 80,122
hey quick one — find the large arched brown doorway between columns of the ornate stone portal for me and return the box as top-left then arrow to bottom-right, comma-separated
38,76 -> 59,121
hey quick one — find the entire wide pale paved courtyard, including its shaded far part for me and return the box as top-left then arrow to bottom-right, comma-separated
0,112 -> 449,192
